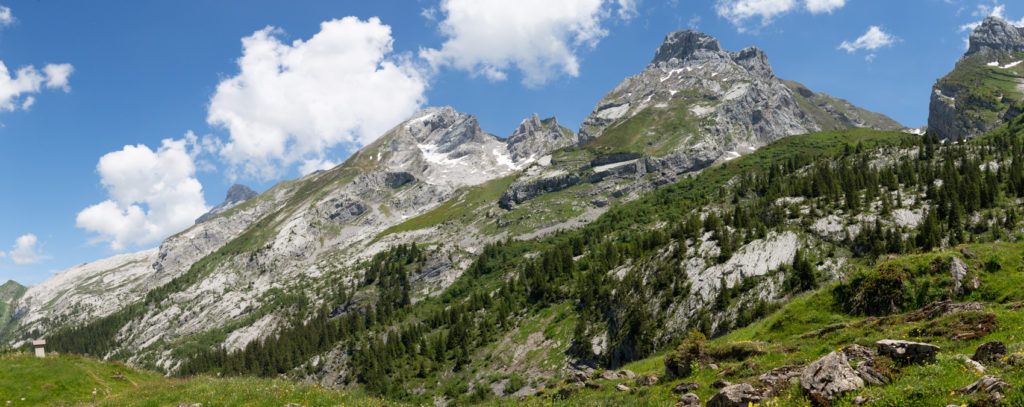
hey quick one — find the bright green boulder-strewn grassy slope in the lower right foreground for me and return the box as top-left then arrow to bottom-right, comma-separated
516,243 -> 1024,406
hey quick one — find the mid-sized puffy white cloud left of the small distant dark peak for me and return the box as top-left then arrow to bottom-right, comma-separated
76,134 -> 209,250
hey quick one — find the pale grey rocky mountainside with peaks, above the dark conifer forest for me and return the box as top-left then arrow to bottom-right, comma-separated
0,27 -> 898,372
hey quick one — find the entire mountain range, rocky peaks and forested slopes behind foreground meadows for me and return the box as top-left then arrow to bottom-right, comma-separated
0,13 -> 1024,401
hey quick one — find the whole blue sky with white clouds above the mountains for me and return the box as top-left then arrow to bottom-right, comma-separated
0,0 -> 1024,284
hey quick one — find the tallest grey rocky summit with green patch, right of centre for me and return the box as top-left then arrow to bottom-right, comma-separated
580,30 -> 902,148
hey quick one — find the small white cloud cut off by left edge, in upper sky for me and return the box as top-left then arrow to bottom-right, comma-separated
0,60 -> 75,112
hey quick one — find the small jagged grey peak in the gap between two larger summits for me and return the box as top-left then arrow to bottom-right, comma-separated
507,113 -> 580,162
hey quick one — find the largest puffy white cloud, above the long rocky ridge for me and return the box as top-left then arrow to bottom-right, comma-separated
207,16 -> 427,179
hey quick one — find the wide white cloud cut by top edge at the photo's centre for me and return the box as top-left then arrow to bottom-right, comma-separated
420,0 -> 637,87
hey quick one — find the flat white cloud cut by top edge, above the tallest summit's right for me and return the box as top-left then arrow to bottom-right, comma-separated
715,0 -> 846,32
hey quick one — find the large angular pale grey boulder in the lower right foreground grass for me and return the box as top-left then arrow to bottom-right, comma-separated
800,352 -> 864,405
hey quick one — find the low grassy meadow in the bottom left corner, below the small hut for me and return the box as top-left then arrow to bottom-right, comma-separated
0,354 -> 400,407
